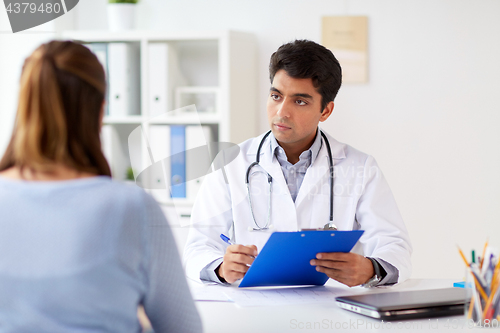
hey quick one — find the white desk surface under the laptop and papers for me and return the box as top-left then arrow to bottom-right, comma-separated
196,279 -> 474,333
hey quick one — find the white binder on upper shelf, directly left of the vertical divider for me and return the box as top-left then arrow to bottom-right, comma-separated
108,43 -> 140,117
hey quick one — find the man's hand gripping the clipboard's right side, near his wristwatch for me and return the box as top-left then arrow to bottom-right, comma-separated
311,252 -> 375,287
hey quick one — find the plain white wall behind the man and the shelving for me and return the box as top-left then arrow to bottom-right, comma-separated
0,0 -> 500,279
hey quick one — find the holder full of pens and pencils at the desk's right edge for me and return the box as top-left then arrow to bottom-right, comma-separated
465,265 -> 500,328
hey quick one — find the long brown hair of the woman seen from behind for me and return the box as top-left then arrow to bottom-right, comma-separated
0,41 -> 111,176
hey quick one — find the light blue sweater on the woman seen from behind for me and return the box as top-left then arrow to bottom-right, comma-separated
0,176 -> 201,333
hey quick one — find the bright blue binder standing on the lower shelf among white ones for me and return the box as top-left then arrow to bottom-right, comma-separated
170,125 -> 186,198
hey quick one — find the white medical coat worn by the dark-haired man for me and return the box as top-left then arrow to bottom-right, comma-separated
184,133 -> 412,282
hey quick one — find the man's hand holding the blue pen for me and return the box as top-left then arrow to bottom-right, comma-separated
215,245 -> 257,283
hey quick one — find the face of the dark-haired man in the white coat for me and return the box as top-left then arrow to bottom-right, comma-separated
267,69 -> 333,150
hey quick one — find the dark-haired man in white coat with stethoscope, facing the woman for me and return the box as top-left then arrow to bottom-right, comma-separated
184,40 -> 412,287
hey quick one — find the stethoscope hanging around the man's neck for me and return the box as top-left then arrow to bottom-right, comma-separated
245,130 -> 337,231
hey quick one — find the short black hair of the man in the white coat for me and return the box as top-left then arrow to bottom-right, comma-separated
269,39 -> 342,112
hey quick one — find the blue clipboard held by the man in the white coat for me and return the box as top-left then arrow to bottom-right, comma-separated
239,230 -> 364,288
